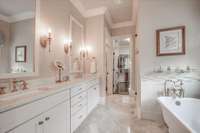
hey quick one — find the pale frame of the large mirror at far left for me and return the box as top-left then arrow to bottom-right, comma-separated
0,0 -> 40,80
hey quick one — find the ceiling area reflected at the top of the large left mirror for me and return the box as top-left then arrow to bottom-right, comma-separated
0,0 -> 35,17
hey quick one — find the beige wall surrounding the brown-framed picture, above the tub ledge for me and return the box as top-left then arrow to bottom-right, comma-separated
139,0 -> 200,74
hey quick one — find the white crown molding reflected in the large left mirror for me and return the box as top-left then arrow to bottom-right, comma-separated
0,12 -> 35,23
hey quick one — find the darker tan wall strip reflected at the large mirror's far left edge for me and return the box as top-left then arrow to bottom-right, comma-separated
0,20 -> 10,73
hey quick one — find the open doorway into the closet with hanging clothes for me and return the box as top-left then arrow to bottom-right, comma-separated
113,36 -> 132,95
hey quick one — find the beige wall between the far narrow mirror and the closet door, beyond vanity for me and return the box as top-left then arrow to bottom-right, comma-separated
86,15 -> 106,97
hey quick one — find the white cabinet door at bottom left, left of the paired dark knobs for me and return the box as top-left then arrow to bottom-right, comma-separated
8,118 -> 44,133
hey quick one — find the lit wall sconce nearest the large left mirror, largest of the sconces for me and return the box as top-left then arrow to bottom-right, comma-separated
40,28 -> 52,52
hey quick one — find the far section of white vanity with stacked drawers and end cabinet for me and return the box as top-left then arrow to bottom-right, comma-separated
70,80 -> 99,133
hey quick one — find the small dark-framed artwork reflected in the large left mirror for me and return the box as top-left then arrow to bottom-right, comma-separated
15,46 -> 27,62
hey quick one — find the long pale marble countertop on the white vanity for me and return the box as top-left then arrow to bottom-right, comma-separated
0,77 -> 97,113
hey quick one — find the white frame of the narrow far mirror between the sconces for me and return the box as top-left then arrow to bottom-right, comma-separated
69,15 -> 84,74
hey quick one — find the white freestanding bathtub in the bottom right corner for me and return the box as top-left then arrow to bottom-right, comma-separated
158,97 -> 200,133
